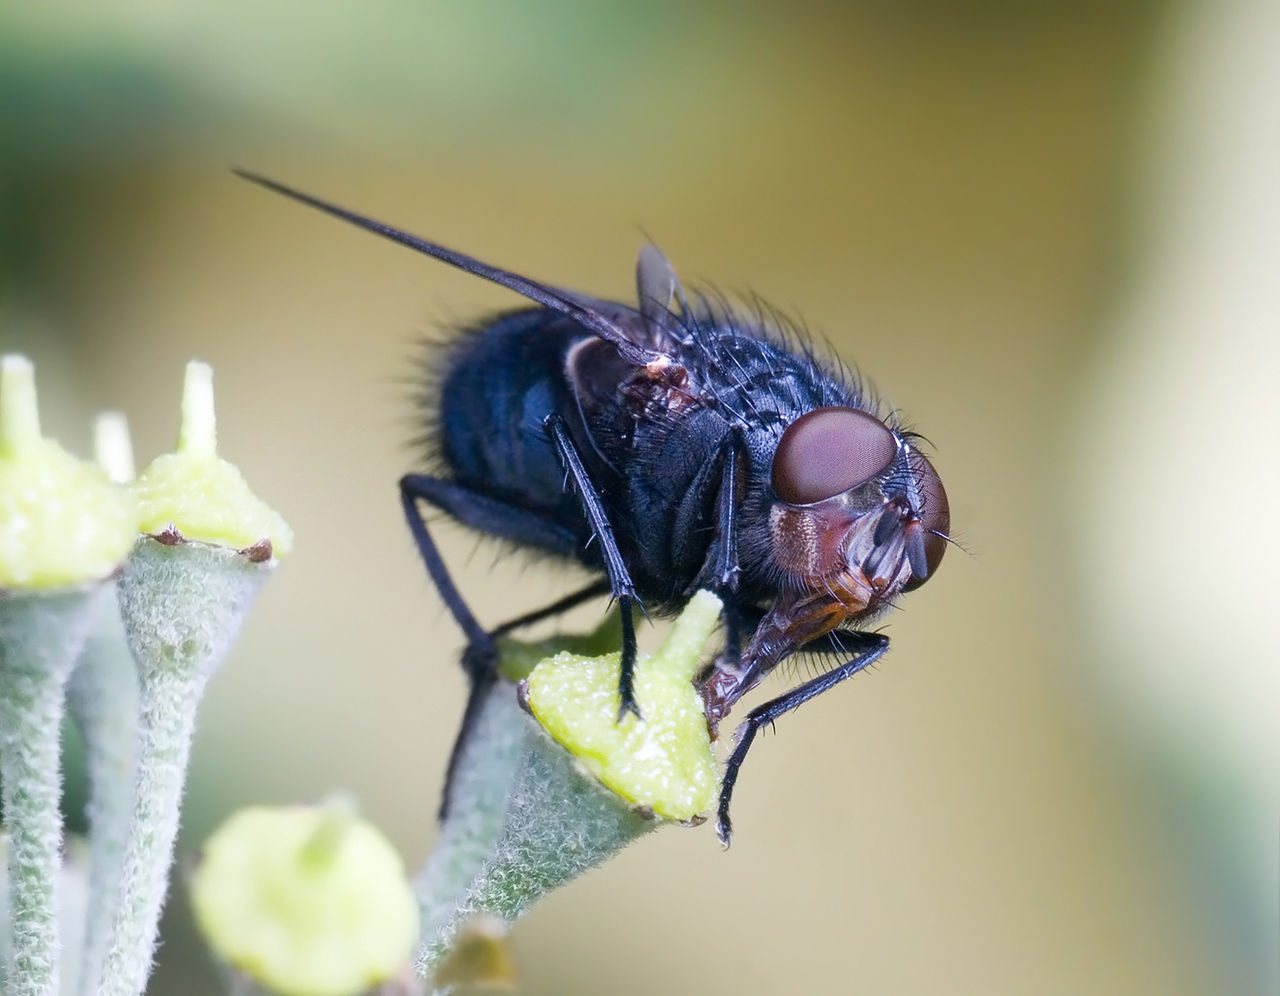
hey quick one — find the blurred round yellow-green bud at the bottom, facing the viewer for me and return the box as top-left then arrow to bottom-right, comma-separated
191,804 -> 417,996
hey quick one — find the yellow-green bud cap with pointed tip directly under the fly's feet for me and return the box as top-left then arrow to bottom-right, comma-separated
527,591 -> 721,821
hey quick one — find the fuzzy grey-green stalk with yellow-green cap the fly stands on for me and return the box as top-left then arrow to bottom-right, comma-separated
413,593 -> 721,991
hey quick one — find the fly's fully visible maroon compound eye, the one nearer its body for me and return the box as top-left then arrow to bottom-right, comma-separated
773,408 -> 897,504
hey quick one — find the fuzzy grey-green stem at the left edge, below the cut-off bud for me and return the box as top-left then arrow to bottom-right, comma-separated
0,589 -> 92,996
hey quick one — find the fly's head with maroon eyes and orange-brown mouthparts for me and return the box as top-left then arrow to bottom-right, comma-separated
750,407 -> 951,659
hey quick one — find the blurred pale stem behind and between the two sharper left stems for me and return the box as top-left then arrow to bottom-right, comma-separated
67,584 -> 138,992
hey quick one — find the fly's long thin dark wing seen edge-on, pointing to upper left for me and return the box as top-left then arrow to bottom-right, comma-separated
232,168 -> 662,366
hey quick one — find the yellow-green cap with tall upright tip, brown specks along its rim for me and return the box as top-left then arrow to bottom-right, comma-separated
132,361 -> 293,557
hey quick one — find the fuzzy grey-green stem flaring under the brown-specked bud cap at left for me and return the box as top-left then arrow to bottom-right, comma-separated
99,536 -> 269,996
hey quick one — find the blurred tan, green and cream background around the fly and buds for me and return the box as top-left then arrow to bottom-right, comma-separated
0,0 -> 1280,996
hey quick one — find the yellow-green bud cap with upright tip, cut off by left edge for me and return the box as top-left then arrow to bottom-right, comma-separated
0,355 -> 138,589
